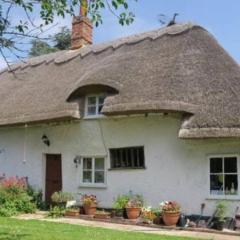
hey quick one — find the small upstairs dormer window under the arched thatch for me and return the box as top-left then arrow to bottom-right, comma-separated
85,95 -> 105,117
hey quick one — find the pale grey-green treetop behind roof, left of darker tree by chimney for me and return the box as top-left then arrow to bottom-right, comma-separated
29,39 -> 57,57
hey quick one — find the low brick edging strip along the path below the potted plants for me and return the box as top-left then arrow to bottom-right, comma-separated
64,214 -> 240,237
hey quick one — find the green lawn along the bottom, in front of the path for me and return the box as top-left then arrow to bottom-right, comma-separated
0,218 -> 203,240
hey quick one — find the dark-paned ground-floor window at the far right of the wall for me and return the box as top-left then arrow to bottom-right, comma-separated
210,156 -> 238,196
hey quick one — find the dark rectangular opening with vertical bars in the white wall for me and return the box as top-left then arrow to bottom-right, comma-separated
110,147 -> 145,169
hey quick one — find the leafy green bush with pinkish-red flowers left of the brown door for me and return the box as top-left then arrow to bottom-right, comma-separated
0,177 -> 36,217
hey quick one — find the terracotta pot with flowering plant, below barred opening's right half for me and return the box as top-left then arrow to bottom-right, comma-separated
125,195 -> 143,219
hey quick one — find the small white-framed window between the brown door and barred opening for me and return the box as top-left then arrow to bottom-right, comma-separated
82,157 -> 105,184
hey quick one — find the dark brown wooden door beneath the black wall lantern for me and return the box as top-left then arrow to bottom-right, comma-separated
45,154 -> 62,203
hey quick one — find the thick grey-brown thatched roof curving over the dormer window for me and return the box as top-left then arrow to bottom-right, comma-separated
0,24 -> 240,138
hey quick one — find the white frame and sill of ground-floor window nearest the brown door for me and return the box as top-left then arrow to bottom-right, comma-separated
80,155 -> 107,188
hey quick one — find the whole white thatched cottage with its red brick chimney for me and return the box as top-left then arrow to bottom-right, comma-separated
0,10 -> 240,215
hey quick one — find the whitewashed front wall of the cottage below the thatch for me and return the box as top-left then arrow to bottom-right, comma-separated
0,115 -> 240,215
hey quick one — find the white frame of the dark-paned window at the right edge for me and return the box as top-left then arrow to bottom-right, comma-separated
207,153 -> 240,200
